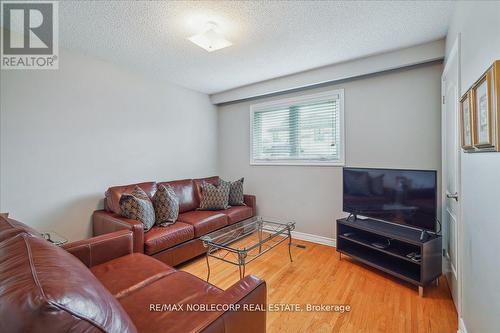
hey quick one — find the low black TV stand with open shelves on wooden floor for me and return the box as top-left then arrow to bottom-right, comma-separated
337,217 -> 442,296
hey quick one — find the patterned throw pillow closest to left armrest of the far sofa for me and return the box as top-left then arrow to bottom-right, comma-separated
120,186 -> 155,231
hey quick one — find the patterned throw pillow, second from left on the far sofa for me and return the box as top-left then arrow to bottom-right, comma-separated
152,185 -> 179,227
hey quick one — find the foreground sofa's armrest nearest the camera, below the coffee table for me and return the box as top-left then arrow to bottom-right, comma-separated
202,275 -> 267,333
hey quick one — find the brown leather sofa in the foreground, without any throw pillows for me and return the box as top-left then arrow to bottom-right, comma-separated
0,217 -> 266,333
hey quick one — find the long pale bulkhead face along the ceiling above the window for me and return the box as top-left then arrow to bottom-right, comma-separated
210,39 -> 445,104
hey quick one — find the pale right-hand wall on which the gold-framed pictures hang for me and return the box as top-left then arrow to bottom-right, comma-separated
446,1 -> 500,333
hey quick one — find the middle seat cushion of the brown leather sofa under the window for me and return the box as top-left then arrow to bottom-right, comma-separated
179,210 -> 228,237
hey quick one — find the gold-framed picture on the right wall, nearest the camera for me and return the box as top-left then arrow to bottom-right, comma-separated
470,61 -> 500,151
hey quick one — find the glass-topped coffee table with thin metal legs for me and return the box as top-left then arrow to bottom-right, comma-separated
201,217 -> 295,281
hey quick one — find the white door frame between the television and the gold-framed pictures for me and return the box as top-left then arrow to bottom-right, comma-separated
441,34 -> 463,321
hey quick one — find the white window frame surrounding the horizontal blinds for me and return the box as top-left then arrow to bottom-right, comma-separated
249,89 -> 345,166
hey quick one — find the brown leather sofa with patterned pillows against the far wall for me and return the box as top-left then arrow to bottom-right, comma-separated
93,176 -> 256,266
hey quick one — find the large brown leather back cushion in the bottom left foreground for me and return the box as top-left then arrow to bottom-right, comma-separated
0,233 -> 137,332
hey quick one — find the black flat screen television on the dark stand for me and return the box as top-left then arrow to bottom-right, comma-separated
343,168 -> 437,232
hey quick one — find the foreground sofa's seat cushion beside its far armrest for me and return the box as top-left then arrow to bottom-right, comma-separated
90,253 -> 176,298
